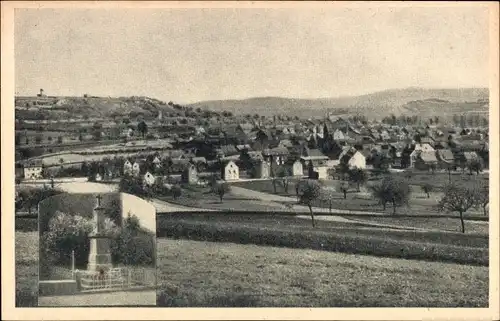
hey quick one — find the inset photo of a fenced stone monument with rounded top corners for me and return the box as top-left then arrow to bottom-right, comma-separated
38,193 -> 156,307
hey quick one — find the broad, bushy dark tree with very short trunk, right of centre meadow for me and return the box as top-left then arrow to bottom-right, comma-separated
371,176 -> 411,214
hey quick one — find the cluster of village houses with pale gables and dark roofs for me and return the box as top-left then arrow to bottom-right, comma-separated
15,117 -> 489,185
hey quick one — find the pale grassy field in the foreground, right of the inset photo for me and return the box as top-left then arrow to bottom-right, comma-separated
158,239 -> 488,307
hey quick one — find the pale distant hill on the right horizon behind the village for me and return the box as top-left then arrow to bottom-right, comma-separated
189,88 -> 489,117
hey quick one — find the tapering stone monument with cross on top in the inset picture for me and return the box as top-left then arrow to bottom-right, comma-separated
87,195 -> 113,272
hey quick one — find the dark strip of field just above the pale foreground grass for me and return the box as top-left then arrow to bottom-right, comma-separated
157,213 -> 488,265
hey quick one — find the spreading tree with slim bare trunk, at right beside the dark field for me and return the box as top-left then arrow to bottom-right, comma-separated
438,184 -> 477,233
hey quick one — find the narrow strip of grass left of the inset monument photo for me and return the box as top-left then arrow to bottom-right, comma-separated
15,231 -> 38,307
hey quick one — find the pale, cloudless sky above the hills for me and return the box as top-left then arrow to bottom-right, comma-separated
14,5 -> 489,103
